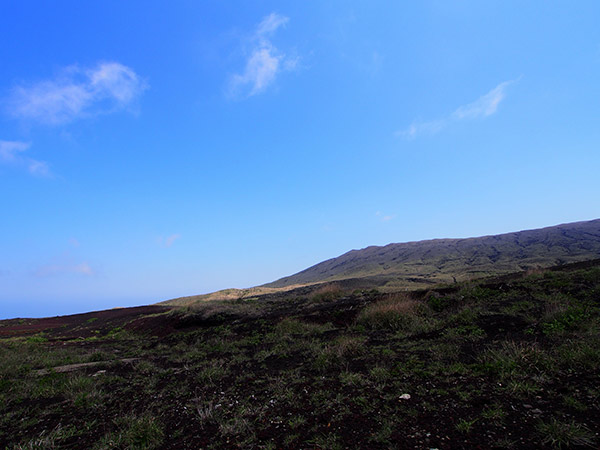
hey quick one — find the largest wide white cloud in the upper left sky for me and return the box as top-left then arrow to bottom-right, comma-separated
8,62 -> 148,125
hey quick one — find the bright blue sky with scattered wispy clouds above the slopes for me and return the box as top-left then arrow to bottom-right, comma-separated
0,0 -> 600,318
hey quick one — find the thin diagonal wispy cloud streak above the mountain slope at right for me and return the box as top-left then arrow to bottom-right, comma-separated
396,78 -> 520,139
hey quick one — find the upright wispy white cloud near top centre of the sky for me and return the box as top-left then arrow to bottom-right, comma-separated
229,13 -> 298,98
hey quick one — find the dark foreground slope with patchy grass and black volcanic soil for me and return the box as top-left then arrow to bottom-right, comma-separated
0,261 -> 600,449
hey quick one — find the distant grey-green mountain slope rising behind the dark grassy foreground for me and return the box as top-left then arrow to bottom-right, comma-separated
263,219 -> 600,288
